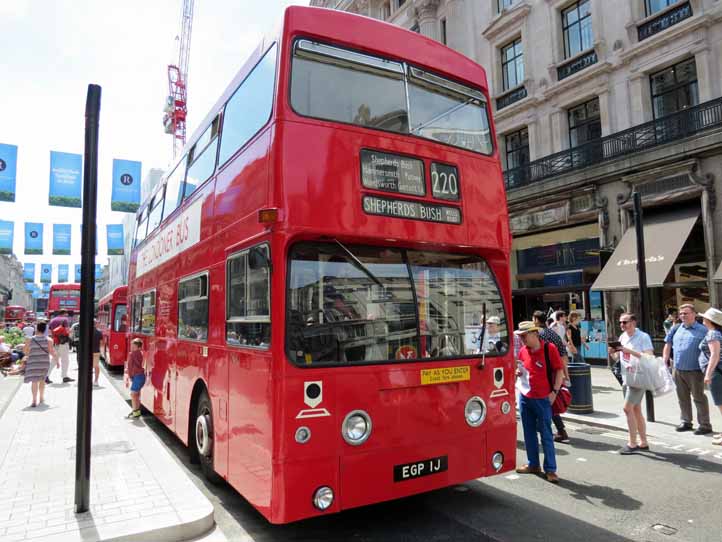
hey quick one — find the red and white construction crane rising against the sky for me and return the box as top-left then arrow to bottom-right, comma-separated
163,0 -> 194,158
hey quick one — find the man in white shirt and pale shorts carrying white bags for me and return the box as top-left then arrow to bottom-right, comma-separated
609,312 -> 654,455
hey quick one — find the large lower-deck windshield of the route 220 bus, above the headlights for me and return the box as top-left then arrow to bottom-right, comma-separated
287,243 -> 508,365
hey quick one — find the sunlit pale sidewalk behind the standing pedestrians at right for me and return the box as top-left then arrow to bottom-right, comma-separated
563,366 -> 722,452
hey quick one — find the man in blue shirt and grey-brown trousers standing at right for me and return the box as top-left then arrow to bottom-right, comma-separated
662,305 -> 712,435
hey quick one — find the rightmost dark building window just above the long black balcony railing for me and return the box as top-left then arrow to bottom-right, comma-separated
649,58 -> 699,118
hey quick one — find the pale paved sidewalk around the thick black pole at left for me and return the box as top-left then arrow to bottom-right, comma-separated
0,357 -> 214,542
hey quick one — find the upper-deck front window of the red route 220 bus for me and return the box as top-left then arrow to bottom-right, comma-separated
291,40 -> 493,154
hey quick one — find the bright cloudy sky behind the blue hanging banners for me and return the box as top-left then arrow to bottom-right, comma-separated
0,0 -> 309,282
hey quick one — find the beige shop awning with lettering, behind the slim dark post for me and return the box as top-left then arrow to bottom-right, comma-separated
592,207 -> 699,290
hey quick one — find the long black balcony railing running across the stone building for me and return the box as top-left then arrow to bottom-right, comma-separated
504,98 -> 722,190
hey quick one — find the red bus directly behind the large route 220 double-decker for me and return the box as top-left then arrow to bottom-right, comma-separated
97,286 -> 128,367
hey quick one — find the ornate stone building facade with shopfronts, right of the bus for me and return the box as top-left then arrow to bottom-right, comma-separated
311,0 -> 722,357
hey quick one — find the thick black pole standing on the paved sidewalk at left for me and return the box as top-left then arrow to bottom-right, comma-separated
75,85 -> 101,514
